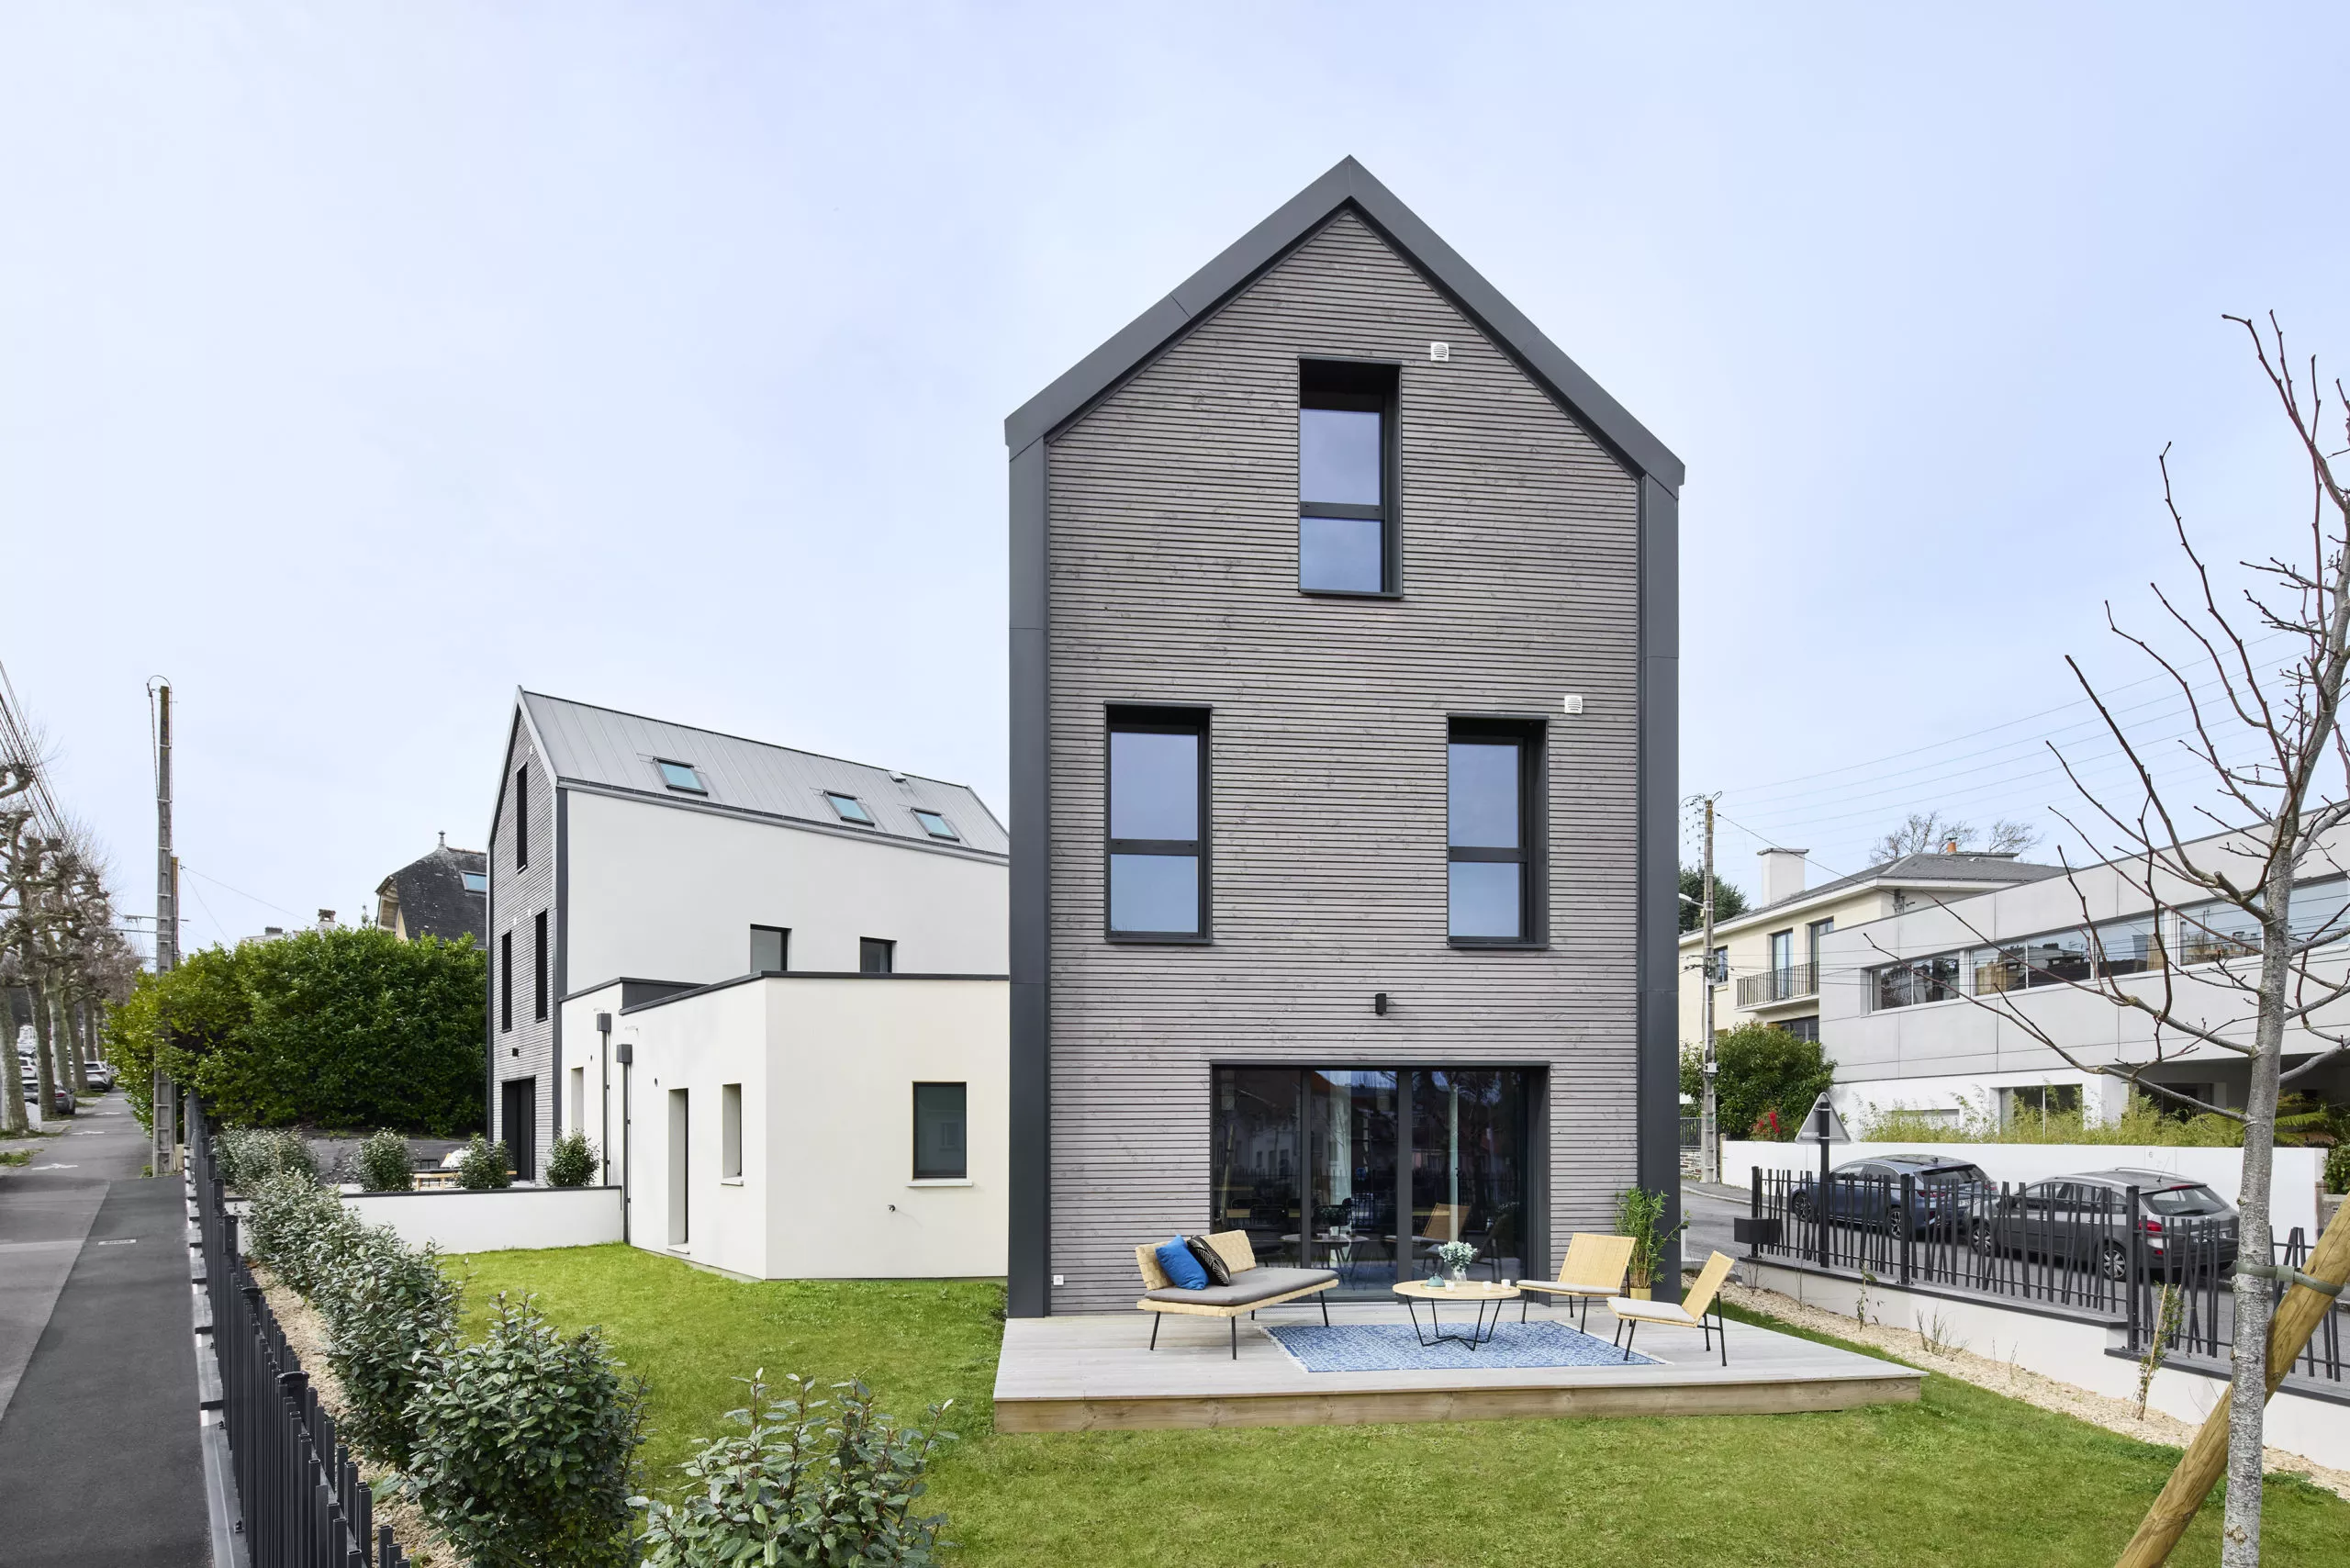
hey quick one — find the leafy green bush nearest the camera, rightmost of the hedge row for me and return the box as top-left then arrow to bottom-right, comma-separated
634,1371 -> 954,1568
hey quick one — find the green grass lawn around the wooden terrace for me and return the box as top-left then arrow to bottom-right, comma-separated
458,1246 -> 2350,1568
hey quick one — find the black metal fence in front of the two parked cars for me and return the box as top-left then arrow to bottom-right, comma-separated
1739,1169 -> 2350,1384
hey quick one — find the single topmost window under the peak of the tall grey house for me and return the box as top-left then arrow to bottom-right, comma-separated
1297,360 -> 1396,592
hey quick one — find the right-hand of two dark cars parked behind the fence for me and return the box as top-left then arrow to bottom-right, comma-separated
1974,1169 -> 2237,1279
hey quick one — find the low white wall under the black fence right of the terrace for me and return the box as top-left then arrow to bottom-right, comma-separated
1732,1260 -> 2350,1469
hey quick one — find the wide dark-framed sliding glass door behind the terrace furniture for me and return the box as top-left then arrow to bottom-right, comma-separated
1208,1068 -> 1539,1295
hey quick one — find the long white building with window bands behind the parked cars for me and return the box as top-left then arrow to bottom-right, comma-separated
1818,834 -> 2350,1121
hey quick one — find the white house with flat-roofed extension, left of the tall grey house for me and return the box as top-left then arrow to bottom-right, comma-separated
488,691 -> 1008,1279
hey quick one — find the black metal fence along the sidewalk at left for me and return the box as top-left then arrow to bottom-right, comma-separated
188,1095 -> 407,1568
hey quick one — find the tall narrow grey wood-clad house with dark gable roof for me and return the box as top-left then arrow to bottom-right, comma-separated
1006,160 -> 1683,1316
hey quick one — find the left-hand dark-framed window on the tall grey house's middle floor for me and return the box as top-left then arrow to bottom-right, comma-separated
1109,708 -> 1208,940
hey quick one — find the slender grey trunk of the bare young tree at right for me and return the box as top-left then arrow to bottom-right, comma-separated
2219,860 -> 2299,1568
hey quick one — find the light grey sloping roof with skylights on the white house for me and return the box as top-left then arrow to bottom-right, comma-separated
515,691 -> 1011,856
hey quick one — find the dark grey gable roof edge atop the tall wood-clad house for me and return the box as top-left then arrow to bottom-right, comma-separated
1003,158 -> 1683,491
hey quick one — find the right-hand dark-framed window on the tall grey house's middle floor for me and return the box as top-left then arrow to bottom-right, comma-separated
1445,720 -> 1541,947
